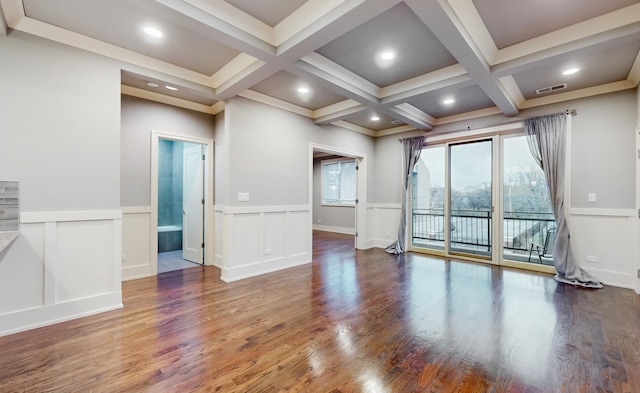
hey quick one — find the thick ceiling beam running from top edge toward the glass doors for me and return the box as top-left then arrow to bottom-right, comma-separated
406,0 -> 519,116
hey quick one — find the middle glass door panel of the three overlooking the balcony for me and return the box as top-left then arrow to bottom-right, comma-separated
449,140 -> 492,258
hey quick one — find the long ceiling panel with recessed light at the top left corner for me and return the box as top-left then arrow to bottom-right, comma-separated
24,0 -> 239,75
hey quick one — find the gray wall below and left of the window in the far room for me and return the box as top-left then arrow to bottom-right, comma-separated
313,158 -> 356,235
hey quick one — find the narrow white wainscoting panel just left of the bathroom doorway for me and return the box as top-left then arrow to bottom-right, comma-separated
122,207 -> 153,281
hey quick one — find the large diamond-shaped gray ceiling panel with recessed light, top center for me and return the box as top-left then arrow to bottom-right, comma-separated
318,3 -> 456,87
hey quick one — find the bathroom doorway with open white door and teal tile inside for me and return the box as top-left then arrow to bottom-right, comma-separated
151,131 -> 213,274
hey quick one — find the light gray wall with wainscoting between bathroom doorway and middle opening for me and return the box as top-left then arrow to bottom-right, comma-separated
218,97 -> 374,281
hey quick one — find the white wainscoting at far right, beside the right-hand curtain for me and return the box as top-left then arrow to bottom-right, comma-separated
570,209 -> 638,289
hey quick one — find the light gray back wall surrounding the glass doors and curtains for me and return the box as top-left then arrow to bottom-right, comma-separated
374,90 -> 639,288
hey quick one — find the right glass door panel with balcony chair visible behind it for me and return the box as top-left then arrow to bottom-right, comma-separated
502,135 -> 555,266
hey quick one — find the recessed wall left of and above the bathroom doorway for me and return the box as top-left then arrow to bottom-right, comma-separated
119,95 -> 217,280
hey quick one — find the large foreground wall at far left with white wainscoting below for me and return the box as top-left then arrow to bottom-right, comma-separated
0,31 -> 122,335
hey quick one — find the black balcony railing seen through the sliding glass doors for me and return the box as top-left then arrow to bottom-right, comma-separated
412,209 -> 555,252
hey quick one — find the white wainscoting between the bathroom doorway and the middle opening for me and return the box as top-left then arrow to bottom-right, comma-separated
215,206 -> 311,282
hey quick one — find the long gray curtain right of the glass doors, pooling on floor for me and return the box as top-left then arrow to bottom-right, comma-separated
524,113 -> 602,288
